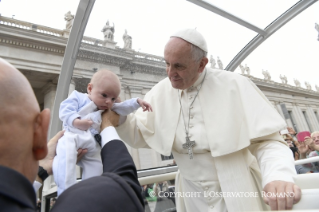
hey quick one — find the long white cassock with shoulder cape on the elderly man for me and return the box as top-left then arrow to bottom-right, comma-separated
117,68 -> 296,212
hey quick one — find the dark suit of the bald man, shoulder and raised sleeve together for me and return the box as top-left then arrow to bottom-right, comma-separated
0,140 -> 144,212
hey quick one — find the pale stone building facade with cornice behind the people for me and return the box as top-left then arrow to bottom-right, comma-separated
0,17 -> 319,172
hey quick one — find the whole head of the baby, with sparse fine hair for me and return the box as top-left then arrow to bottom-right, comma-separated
87,69 -> 121,110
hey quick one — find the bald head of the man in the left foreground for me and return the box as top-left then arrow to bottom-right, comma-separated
0,59 -> 50,181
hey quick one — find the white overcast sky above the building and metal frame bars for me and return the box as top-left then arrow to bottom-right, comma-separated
0,0 -> 319,90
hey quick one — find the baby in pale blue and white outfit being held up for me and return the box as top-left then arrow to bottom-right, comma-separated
53,70 -> 152,195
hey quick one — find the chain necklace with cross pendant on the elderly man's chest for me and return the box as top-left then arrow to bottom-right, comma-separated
177,71 -> 207,159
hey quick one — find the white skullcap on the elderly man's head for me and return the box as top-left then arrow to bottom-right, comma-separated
171,29 -> 208,52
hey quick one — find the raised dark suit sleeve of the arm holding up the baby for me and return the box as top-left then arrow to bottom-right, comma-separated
51,140 -> 144,212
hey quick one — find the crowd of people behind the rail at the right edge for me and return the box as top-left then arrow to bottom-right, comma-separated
281,127 -> 319,174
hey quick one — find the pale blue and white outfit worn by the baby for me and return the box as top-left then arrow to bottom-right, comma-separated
53,91 -> 139,196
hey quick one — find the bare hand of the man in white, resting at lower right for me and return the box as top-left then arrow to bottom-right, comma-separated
263,180 -> 301,210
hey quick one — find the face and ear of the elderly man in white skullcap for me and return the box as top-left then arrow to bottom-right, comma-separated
164,38 -> 208,89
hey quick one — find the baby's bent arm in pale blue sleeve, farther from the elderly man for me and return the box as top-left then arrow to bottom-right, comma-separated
59,91 -> 93,130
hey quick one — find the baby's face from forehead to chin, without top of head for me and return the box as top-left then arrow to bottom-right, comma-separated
87,81 -> 120,110
